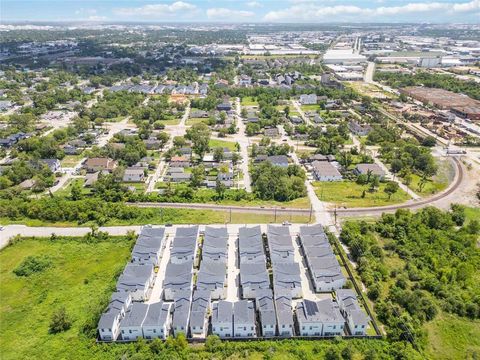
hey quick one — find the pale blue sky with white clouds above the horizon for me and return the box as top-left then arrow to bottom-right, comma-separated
0,0 -> 480,24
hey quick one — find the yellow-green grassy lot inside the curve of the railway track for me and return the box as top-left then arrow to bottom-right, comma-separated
313,181 -> 410,207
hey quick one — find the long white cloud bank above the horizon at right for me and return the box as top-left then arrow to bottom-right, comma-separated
264,0 -> 480,22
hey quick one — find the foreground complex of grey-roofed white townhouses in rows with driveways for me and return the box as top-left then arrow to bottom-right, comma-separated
98,225 -> 371,342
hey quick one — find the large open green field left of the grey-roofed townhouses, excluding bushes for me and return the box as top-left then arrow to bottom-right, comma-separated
0,238 -> 131,360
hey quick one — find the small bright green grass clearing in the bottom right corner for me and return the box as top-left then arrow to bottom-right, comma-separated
426,314 -> 480,360
